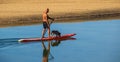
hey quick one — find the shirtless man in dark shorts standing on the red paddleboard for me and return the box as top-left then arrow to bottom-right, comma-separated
42,8 -> 54,38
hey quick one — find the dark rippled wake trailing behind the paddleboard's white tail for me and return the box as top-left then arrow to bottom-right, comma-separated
0,38 -> 20,48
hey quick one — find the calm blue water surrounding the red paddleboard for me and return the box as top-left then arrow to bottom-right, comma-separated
0,20 -> 120,62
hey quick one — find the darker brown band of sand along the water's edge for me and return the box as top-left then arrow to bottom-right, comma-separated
0,8 -> 120,28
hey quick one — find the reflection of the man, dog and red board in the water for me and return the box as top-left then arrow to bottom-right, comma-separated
42,38 -> 76,62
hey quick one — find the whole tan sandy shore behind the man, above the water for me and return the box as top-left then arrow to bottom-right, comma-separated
0,0 -> 120,27
